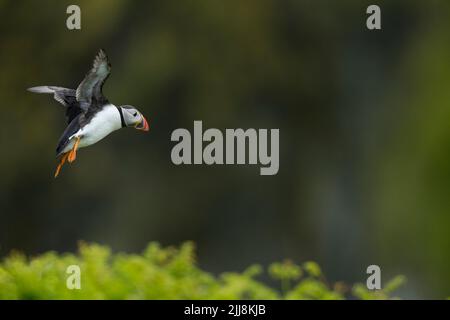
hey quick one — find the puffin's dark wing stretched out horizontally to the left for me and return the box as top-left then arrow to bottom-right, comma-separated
28,86 -> 83,123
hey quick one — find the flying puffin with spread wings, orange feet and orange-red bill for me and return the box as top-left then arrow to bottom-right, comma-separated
28,49 -> 149,178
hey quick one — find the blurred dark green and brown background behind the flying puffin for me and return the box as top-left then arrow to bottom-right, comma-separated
0,0 -> 450,298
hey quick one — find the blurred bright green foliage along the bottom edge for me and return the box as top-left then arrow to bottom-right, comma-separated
0,242 -> 404,299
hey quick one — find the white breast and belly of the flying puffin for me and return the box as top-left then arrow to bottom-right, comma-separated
63,104 -> 122,152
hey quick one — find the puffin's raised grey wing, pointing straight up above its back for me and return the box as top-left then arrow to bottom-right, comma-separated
75,49 -> 111,111
